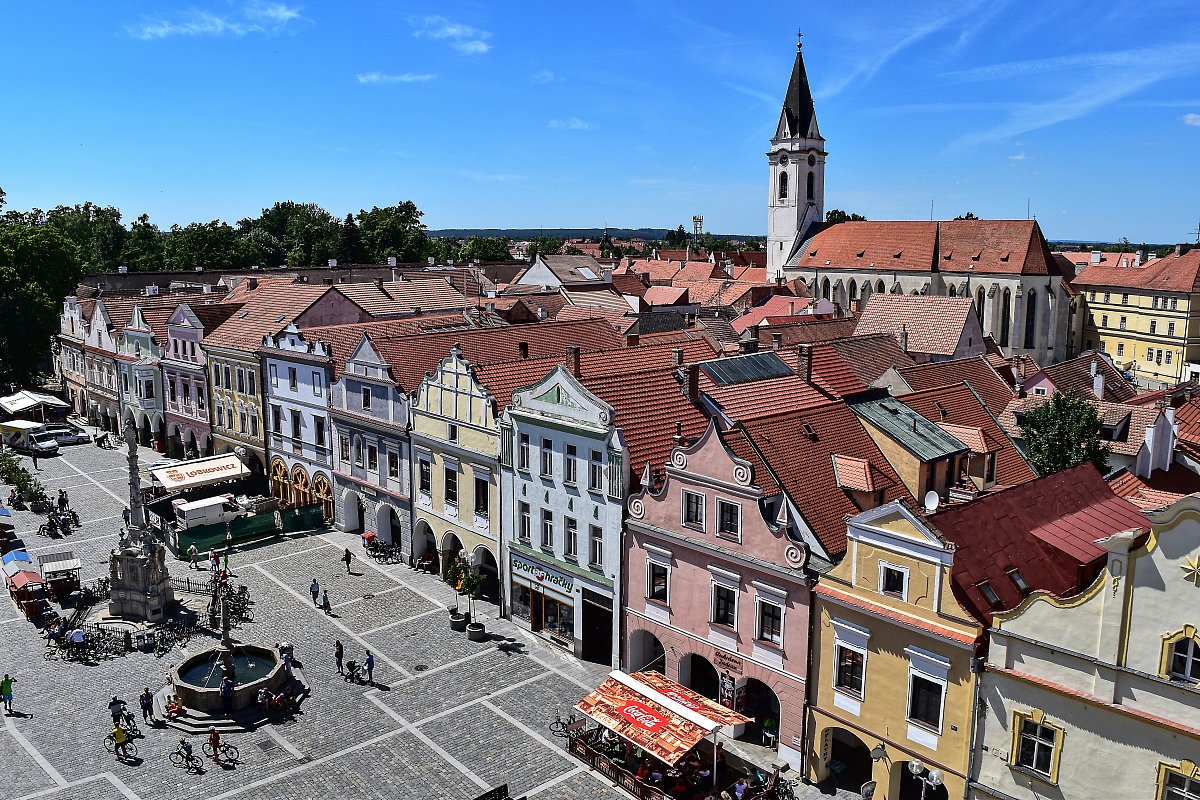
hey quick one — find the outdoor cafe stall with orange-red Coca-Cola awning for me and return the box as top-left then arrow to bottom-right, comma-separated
570,670 -> 750,800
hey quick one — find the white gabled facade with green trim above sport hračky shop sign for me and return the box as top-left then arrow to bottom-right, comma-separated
500,366 -> 629,668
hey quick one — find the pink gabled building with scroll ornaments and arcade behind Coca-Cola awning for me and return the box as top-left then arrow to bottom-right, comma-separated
624,425 -> 812,768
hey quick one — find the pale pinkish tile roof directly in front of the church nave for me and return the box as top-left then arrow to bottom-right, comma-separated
854,294 -> 974,355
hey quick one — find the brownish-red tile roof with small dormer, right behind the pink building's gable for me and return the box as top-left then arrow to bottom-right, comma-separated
738,401 -> 913,558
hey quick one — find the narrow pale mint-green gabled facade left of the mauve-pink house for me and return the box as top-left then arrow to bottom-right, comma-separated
115,306 -> 166,451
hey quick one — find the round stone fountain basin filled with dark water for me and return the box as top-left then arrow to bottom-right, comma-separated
170,644 -> 292,714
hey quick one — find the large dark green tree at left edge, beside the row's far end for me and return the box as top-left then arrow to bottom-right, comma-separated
0,225 -> 86,383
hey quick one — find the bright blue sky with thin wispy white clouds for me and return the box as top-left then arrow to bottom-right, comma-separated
0,0 -> 1200,242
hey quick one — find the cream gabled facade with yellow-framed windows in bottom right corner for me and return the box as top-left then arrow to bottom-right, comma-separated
972,497 -> 1200,800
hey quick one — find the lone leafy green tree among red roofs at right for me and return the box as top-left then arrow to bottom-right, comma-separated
1020,390 -> 1110,475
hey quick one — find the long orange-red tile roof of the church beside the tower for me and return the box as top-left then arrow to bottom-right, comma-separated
791,219 -> 1057,275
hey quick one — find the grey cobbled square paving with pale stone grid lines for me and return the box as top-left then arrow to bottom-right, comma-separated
0,445 -> 648,800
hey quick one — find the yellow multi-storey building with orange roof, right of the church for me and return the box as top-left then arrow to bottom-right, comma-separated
1072,246 -> 1200,389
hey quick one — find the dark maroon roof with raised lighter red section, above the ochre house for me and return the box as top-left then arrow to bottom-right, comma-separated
930,462 -> 1148,625
